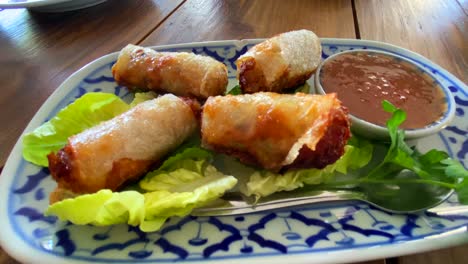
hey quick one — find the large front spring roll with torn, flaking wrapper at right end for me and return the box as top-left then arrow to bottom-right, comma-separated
201,92 -> 350,171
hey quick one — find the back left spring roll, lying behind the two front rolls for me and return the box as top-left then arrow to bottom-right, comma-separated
112,44 -> 228,99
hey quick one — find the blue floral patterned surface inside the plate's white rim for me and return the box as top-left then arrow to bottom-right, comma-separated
4,39 -> 468,263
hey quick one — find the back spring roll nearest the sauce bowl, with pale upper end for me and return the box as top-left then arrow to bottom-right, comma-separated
236,30 -> 322,93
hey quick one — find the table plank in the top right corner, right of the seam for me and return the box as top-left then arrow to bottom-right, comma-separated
355,0 -> 468,83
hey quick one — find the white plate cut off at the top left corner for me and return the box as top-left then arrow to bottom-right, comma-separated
0,0 -> 106,12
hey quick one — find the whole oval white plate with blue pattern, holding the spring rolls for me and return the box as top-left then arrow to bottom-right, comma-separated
0,39 -> 468,263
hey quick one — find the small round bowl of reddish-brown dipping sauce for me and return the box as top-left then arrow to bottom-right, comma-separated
315,50 -> 455,140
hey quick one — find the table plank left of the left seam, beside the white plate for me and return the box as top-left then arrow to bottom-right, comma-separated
0,0 -> 182,166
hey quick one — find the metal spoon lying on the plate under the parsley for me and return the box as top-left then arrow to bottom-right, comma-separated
192,173 -> 453,216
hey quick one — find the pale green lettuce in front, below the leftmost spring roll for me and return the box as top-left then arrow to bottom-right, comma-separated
46,148 -> 237,232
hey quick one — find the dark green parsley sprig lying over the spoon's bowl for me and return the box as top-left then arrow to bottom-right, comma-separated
321,101 -> 468,204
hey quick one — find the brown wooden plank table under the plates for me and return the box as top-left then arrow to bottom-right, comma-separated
0,0 -> 468,264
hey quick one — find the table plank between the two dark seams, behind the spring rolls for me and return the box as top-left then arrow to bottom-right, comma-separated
141,0 -> 356,46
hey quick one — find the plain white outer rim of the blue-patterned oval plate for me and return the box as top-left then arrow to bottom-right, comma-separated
0,38 -> 468,263
